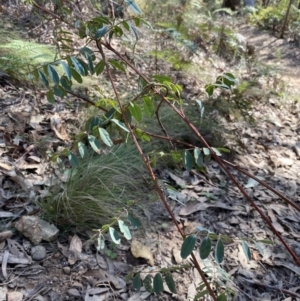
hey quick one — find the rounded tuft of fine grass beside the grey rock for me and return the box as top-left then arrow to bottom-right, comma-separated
39,145 -> 151,228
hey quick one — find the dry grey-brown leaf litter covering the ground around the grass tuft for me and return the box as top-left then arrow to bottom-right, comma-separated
0,2 -> 300,301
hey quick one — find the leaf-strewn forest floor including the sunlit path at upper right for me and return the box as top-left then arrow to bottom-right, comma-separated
0,4 -> 300,301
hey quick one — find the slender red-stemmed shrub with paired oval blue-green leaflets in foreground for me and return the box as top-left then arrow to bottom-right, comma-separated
27,0 -> 300,300
